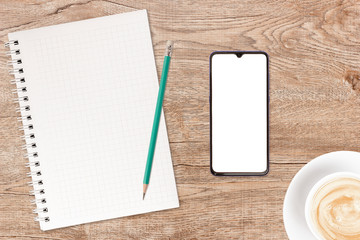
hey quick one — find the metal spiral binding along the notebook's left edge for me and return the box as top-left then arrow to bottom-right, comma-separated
5,40 -> 50,222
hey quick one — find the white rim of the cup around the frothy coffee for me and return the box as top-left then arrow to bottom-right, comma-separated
305,172 -> 360,240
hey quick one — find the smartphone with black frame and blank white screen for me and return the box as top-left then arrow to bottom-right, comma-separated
209,51 -> 269,176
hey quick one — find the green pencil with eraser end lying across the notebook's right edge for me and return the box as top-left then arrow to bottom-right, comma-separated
143,41 -> 174,200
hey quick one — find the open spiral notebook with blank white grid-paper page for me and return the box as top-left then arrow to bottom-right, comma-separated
7,10 -> 179,230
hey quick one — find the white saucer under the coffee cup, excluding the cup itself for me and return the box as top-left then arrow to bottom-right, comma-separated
283,151 -> 360,240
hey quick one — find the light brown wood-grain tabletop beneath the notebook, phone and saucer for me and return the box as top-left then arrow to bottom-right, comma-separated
0,0 -> 360,239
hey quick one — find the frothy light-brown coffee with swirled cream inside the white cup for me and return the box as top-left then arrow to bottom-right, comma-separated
309,177 -> 360,240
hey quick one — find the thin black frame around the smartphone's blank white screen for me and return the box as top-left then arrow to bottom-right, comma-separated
209,51 -> 270,176
